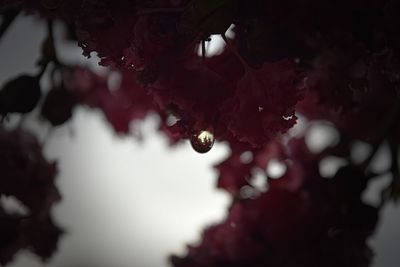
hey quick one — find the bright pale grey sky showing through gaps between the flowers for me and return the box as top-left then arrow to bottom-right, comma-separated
0,13 -> 400,267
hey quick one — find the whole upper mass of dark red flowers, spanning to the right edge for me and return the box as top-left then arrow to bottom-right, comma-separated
15,0 -> 398,148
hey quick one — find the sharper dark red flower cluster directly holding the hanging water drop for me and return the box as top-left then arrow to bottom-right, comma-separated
0,1 -> 303,147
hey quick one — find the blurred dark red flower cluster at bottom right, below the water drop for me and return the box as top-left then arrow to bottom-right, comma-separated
171,139 -> 378,267
